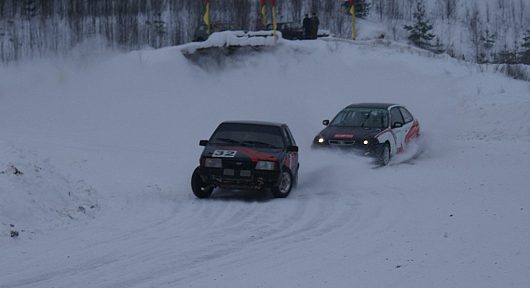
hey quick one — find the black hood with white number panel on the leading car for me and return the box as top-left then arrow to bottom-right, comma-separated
202,145 -> 283,162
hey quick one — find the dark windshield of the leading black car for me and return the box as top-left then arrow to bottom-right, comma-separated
210,123 -> 284,149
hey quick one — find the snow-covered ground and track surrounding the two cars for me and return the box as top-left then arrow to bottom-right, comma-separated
0,40 -> 530,288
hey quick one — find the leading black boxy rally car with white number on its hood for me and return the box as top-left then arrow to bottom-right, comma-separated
191,121 -> 299,198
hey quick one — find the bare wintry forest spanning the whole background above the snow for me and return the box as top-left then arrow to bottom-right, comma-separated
0,0 -> 530,62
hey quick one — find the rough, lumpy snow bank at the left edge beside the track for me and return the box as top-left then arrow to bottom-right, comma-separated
0,142 -> 99,238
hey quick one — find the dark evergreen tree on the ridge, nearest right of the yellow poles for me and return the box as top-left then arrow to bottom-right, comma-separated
404,0 -> 434,49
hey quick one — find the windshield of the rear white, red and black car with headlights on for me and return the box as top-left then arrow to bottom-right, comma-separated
330,108 -> 388,128
